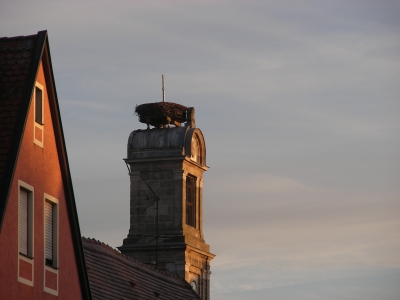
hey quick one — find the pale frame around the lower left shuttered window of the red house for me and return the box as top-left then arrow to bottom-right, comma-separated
17,180 -> 35,286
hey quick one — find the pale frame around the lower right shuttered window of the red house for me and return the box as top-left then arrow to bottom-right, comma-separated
43,193 -> 59,296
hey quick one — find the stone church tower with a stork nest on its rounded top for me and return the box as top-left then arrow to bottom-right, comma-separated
118,102 -> 214,300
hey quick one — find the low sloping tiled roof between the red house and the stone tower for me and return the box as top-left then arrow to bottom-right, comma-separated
82,238 -> 200,300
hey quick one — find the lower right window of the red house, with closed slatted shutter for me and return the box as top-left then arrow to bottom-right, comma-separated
44,195 -> 58,268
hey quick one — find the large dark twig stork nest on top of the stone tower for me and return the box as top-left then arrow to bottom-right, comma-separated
135,102 -> 188,127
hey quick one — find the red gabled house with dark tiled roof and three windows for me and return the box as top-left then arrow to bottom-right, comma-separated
0,31 -> 91,300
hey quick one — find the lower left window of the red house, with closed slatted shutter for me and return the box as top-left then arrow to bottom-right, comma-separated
19,187 -> 33,257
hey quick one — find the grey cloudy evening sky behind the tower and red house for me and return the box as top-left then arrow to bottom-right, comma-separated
0,0 -> 400,300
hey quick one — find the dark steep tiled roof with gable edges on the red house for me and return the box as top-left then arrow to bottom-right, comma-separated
0,31 -> 91,299
